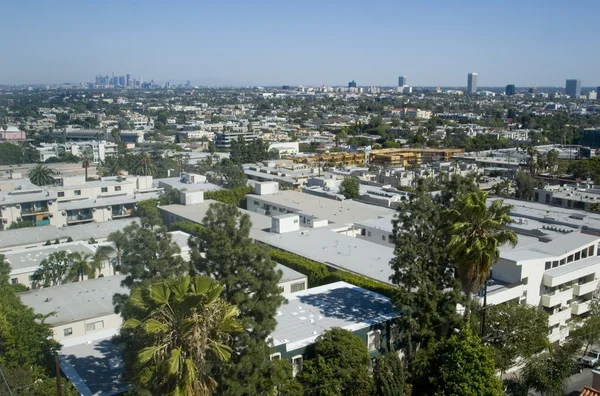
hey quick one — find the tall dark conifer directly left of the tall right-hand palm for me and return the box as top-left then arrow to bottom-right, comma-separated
390,180 -> 461,362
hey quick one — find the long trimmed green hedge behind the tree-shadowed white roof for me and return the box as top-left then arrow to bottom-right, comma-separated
271,249 -> 394,298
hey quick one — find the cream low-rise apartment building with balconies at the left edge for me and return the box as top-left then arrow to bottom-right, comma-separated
0,176 -> 162,230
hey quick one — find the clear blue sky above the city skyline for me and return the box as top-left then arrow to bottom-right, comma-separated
0,0 -> 600,87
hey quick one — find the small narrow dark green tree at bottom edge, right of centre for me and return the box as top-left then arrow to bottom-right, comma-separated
373,352 -> 404,396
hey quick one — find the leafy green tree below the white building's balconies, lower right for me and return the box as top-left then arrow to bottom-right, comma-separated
483,303 -> 548,372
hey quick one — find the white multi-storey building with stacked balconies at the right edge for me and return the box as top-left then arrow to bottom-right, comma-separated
487,232 -> 600,342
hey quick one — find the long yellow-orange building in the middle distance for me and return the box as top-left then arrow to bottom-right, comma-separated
369,148 -> 465,166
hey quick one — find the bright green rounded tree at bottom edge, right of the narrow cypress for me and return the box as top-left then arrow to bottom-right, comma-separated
412,325 -> 504,396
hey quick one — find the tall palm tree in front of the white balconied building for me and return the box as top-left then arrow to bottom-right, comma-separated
447,191 -> 517,320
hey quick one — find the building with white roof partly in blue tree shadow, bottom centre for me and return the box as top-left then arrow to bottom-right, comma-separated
271,282 -> 398,375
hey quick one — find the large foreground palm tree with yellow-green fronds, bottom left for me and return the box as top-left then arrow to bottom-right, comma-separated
121,275 -> 242,396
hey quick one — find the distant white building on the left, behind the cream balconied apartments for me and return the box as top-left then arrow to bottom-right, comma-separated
36,140 -> 118,165
